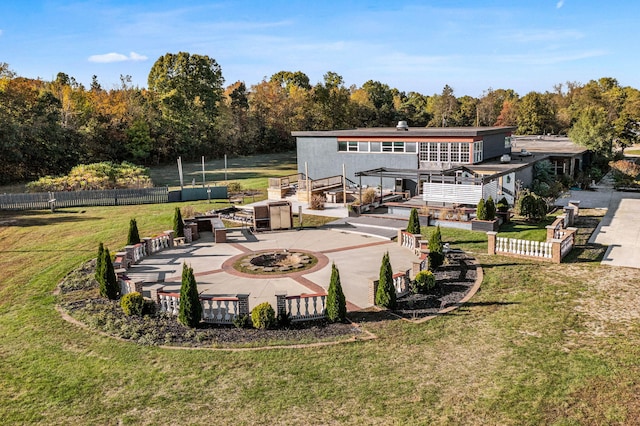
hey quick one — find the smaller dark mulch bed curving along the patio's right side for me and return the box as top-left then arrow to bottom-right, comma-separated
394,251 -> 477,319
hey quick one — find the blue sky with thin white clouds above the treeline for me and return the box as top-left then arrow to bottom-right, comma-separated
0,0 -> 640,97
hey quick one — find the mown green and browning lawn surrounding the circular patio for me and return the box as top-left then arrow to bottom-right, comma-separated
0,174 -> 640,425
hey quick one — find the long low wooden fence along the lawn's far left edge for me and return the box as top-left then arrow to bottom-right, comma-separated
0,187 -> 169,210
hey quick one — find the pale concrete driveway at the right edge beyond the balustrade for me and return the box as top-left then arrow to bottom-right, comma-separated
556,171 -> 640,268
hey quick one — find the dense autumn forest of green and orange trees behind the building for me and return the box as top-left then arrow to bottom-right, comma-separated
0,52 -> 640,184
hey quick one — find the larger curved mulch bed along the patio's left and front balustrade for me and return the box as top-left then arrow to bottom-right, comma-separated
58,260 -> 363,348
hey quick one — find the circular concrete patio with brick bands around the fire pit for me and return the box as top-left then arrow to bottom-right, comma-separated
127,228 -> 417,310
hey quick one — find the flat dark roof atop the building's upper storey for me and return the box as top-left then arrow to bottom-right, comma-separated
291,127 -> 516,138
